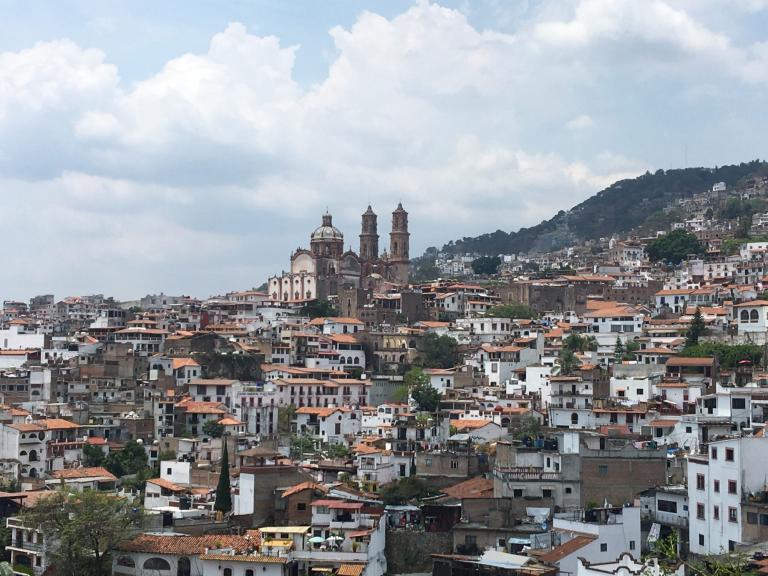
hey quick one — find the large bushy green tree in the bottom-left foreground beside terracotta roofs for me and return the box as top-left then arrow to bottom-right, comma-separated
22,490 -> 143,576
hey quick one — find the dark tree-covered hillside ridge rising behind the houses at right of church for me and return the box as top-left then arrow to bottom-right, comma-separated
430,160 -> 768,255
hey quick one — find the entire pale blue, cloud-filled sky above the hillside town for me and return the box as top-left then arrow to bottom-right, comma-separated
0,0 -> 768,299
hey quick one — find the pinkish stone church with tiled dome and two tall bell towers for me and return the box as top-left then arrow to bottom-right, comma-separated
268,204 -> 410,303
